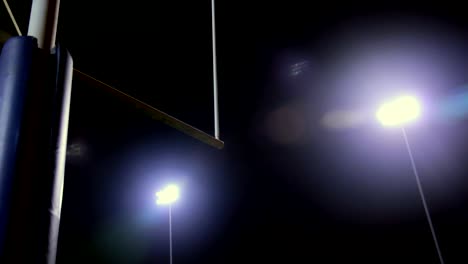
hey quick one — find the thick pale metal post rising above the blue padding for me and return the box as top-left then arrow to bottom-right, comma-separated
28,0 -> 60,51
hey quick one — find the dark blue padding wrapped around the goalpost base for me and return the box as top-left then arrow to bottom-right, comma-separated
0,37 -> 73,263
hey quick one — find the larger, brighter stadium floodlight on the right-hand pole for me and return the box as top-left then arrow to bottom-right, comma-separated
376,96 -> 421,126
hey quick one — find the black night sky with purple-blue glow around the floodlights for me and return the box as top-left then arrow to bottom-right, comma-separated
4,0 -> 468,264
